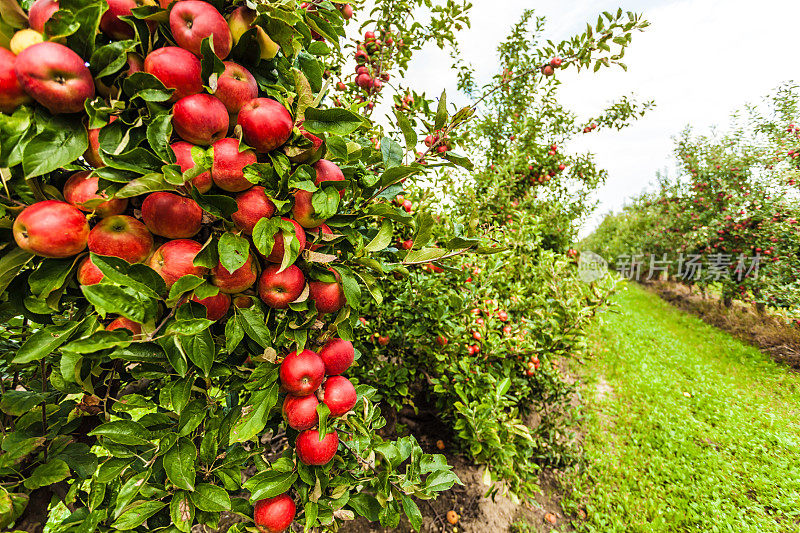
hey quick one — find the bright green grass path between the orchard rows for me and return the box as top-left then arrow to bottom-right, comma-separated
572,285 -> 800,532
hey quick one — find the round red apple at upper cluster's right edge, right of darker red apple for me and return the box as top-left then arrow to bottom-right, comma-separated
237,98 -> 294,153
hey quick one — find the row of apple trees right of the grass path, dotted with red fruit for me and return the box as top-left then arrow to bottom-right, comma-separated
583,85 -> 800,311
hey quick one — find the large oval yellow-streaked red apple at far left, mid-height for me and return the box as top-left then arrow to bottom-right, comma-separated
13,200 -> 89,258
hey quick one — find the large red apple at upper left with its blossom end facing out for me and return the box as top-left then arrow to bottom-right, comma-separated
14,42 -> 94,114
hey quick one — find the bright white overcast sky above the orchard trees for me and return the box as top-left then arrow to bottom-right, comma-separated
398,0 -> 800,235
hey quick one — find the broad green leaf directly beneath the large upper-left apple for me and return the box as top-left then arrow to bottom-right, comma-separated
22,117 -> 89,178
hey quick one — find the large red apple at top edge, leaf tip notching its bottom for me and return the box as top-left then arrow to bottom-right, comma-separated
169,0 -> 232,59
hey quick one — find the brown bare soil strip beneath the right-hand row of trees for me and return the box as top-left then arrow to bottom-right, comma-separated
643,281 -> 800,369
